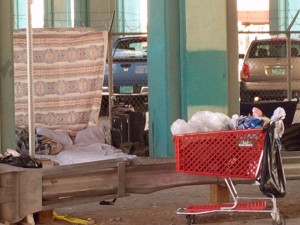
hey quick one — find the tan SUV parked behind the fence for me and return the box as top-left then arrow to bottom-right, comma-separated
240,37 -> 300,102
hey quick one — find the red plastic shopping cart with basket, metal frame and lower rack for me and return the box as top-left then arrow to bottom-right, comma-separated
173,129 -> 285,225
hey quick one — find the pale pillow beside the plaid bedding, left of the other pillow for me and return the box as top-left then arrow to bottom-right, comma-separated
36,127 -> 73,146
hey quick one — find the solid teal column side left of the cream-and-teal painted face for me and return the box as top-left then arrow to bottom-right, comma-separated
148,0 -> 181,157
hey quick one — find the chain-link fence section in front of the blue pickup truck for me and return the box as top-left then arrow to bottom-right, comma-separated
99,33 -> 148,143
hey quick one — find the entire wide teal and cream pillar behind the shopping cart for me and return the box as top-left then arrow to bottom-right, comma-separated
148,0 -> 239,157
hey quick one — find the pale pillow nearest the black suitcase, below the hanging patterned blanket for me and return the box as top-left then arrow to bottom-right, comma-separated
74,124 -> 105,145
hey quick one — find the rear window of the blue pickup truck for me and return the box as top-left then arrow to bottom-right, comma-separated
114,40 -> 147,59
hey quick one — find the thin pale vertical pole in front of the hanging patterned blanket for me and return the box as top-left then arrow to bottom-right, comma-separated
26,0 -> 35,155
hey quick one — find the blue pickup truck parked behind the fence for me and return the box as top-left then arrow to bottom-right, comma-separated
100,36 -> 148,116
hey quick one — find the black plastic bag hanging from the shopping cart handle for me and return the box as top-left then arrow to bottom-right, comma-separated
259,123 -> 286,198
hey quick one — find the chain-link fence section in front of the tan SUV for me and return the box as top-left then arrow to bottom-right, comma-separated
239,31 -> 300,125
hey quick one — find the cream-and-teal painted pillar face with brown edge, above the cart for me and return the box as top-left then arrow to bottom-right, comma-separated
181,0 -> 239,119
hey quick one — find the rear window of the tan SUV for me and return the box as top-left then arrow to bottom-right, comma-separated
249,41 -> 300,58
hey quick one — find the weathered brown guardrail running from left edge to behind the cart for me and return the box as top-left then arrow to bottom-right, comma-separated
0,157 -> 260,222
